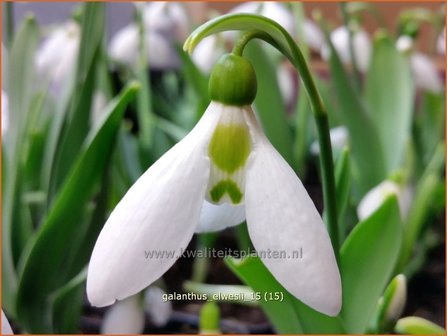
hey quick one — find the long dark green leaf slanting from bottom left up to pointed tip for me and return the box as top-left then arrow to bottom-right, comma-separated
17,84 -> 138,333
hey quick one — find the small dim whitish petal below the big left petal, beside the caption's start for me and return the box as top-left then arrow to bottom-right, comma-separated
144,286 -> 172,327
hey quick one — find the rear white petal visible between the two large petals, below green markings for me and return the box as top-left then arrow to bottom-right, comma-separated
196,201 -> 245,233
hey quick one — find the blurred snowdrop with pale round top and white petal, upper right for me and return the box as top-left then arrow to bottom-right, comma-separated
396,35 -> 444,93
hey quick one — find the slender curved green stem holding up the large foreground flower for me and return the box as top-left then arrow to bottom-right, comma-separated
233,30 -> 340,261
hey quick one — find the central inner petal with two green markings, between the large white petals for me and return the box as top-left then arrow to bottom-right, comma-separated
206,106 -> 251,205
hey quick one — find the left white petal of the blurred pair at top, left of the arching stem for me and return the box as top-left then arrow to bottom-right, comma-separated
109,24 -> 138,65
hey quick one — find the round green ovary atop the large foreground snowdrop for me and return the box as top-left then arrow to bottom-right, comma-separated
208,54 -> 257,106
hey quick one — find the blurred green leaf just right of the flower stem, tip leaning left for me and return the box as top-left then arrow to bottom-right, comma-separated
326,32 -> 386,194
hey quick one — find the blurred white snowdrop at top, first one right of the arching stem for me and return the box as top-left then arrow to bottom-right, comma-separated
321,26 -> 371,72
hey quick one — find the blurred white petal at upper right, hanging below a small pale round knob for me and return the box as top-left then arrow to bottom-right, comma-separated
410,52 -> 443,92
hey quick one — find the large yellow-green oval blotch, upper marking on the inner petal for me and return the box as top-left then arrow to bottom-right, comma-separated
208,124 -> 251,174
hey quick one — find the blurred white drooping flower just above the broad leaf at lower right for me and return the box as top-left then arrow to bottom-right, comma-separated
357,180 -> 413,220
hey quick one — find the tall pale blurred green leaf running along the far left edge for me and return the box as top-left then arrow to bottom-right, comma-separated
2,17 -> 39,316
